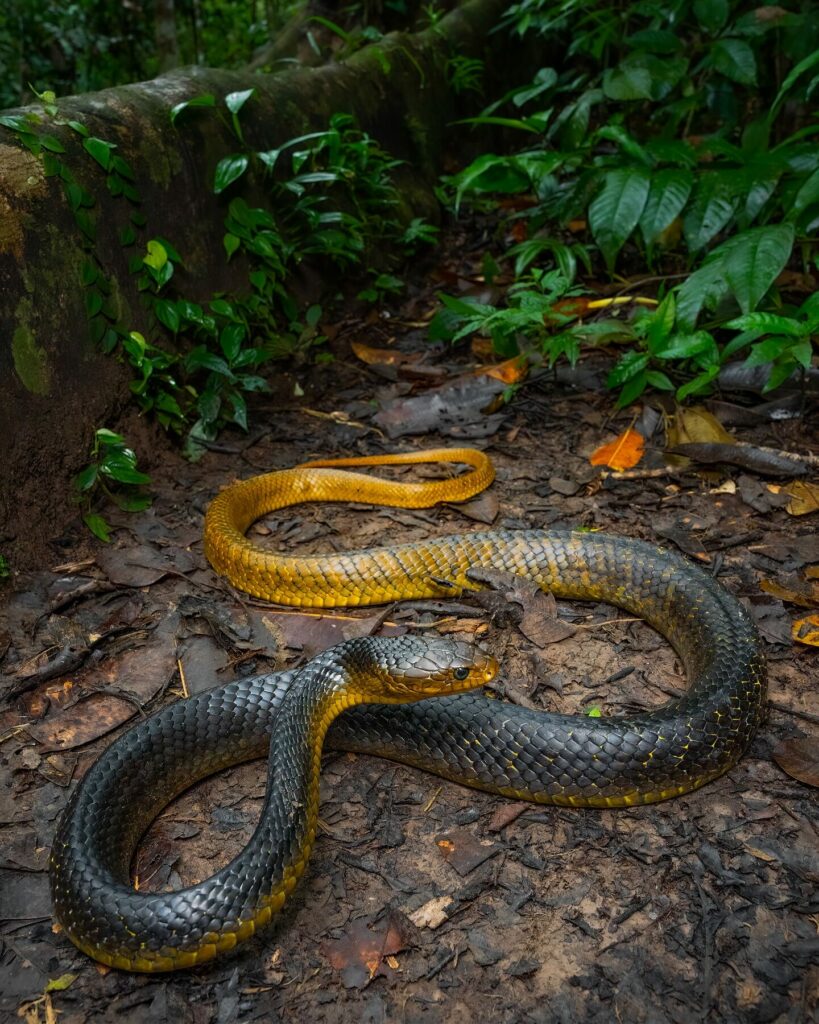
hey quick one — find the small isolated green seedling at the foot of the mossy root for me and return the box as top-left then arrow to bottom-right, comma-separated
74,427 -> 150,543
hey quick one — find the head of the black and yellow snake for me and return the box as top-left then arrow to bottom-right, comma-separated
362,637 -> 498,703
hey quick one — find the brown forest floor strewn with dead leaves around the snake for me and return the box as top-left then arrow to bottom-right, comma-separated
0,226 -> 819,1024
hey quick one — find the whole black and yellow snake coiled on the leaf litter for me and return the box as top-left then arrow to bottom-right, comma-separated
49,449 -> 767,972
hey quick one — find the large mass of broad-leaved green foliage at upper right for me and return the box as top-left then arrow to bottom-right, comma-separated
433,0 -> 819,406
